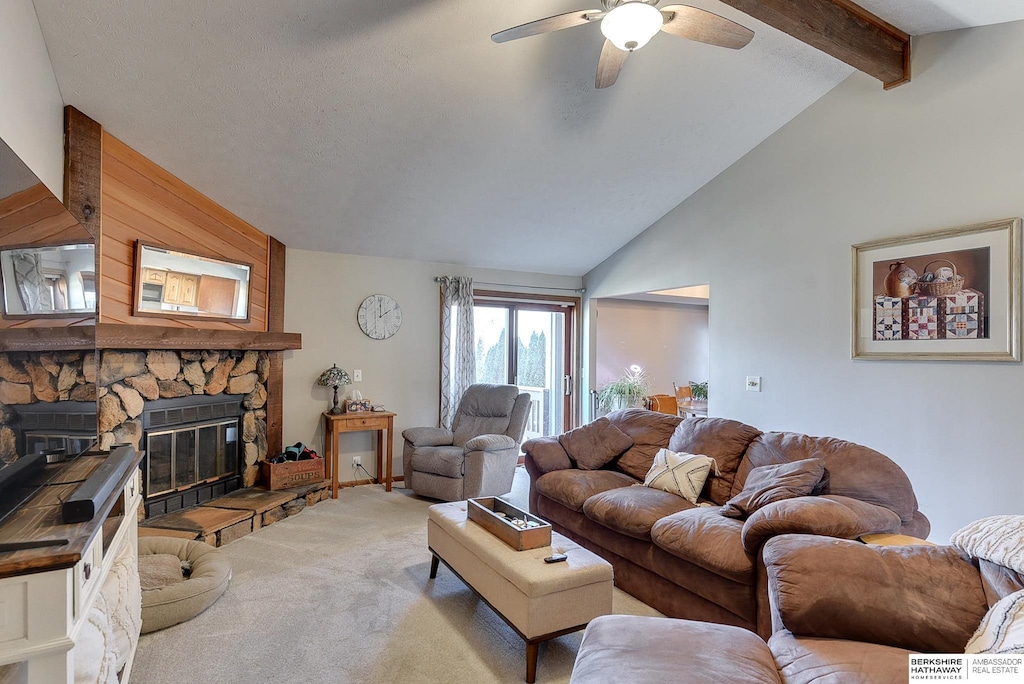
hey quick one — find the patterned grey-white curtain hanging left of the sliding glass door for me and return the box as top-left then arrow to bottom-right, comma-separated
437,275 -> 476,429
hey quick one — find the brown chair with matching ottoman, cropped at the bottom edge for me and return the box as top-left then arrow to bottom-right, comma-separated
570,535 -> 1024,684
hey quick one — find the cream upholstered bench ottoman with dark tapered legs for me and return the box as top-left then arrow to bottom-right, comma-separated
427,501 -> 612,682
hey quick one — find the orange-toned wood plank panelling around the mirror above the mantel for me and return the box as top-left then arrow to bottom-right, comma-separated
99,132 -> 270,332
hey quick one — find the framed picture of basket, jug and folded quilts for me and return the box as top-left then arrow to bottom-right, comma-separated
853,218 -> 1021,361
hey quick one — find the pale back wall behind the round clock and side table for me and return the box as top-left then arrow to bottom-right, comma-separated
284,249 -> 581,481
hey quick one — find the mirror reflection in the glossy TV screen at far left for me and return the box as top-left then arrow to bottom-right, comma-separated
0,244 -> 96,318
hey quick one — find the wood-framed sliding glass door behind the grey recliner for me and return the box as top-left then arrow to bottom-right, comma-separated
473,298 -> 574,440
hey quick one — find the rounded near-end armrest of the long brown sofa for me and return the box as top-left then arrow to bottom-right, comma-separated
742,495 -> 902,554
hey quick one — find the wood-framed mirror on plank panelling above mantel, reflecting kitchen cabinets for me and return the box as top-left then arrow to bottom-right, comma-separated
135,241 -> 252,322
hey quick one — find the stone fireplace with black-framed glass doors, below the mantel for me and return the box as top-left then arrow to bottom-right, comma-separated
96,349 -> 269,515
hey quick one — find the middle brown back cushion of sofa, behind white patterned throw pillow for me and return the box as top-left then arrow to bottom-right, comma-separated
669,418 -> 761,506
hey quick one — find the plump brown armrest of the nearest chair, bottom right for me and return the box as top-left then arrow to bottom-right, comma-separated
763,535 -> 988,653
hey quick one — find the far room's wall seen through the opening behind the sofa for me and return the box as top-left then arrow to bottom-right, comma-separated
591,299 -> 709,394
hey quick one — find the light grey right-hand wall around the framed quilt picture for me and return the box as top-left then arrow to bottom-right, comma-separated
585,23 -> 1024,541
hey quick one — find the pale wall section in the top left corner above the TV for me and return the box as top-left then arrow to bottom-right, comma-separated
0,0 -> 63,198
